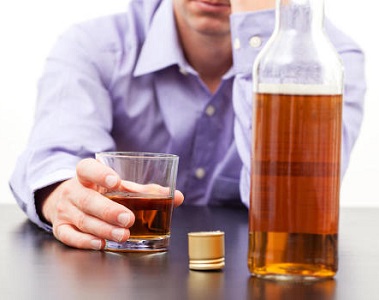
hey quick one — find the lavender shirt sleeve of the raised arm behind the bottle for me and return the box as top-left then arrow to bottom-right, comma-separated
231,11 -> 366,207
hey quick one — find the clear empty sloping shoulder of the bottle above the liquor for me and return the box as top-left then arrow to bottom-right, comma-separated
253,33 -> 343,89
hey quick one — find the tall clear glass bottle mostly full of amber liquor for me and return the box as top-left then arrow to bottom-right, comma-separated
248,0 -> 343,280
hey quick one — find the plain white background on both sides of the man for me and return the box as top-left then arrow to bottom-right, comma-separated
0,0 -> 379,206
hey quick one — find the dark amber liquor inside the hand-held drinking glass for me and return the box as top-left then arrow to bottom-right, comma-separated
104,191 -> 173,239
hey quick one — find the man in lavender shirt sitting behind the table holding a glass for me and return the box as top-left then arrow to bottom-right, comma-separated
11,0 -> 365,250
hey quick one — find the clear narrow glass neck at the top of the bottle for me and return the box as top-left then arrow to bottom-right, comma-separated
276,0 -> 324,32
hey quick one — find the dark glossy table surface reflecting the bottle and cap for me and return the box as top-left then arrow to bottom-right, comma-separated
0,204 -> 379,300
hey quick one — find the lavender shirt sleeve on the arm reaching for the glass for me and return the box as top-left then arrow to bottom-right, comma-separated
10,26 -> 114,230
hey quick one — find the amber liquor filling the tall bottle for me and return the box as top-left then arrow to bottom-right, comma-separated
248,88 -> 342,280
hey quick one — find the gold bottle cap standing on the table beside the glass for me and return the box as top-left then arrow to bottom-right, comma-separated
188,231 -> 225,270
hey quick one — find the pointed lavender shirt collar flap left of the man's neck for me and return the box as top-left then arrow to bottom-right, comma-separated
134,0 -> 188,76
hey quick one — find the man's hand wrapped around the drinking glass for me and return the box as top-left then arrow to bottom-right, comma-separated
36,159 -> 184,250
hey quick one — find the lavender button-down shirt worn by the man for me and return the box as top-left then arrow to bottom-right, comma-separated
10,0 -> 365,229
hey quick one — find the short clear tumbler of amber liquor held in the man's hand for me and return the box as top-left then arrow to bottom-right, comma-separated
96,152 -> 179,252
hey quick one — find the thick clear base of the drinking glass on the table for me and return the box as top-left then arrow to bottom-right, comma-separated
104,236 -> 170,252
